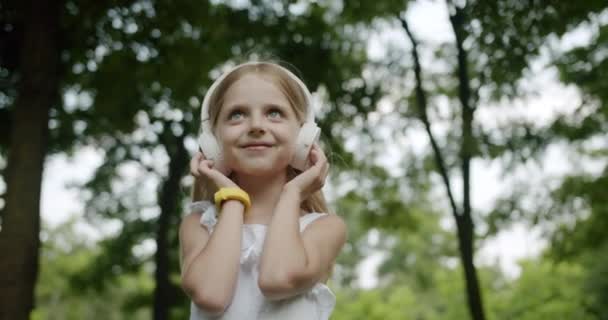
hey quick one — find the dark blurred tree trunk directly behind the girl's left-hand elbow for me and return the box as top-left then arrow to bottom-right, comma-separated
153,136 -> 188,320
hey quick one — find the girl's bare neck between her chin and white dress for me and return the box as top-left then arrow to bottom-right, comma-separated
235,174 -> 287,224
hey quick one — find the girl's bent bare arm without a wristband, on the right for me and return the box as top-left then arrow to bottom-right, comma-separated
258,185 -> 346,299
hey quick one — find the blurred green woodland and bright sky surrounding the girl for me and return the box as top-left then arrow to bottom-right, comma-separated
0,0 -> 608,320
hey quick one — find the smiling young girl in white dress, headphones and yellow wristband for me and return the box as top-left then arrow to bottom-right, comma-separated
180,62 -> 346,320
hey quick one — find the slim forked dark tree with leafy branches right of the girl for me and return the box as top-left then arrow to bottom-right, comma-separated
334,1 -> 605,319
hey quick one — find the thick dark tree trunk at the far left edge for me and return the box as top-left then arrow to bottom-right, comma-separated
0,0 -> 61,320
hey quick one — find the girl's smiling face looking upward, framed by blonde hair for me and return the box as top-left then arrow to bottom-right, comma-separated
216,74 -> 300,176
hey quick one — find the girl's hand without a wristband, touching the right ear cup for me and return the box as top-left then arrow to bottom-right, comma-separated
285,144 -> 329,200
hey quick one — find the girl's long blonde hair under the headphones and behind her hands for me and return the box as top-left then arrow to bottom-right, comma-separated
192,61 -> 329,213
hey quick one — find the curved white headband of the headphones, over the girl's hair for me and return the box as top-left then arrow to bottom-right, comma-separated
201,61 -> 315,131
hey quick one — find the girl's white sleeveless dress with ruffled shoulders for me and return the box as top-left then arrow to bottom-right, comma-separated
190,201 -> 336,320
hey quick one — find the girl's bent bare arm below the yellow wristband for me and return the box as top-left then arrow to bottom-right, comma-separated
179,200 -> 245,314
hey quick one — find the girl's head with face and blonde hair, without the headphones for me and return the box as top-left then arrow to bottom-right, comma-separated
194,62 -> 327,211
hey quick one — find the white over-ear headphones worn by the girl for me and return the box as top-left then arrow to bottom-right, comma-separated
198,62 -> 321,172
